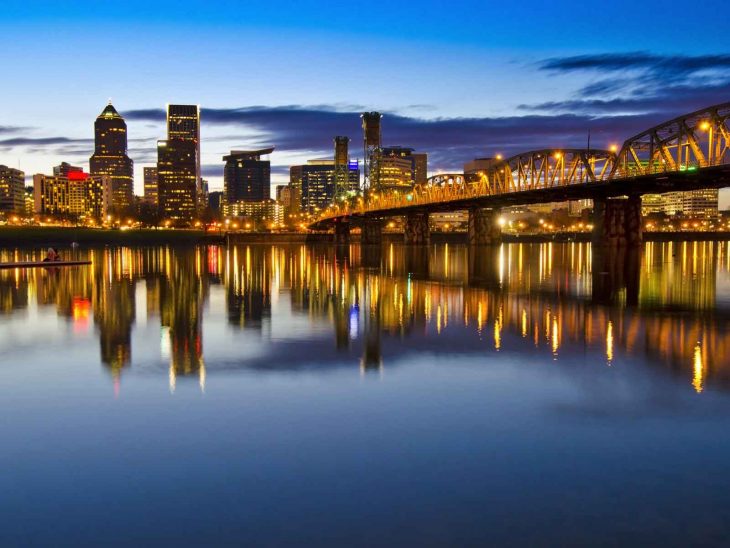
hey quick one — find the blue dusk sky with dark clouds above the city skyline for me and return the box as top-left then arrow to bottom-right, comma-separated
0,0 -> 730,208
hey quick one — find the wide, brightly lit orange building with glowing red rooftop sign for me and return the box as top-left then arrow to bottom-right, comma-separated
33,166 -> 113,222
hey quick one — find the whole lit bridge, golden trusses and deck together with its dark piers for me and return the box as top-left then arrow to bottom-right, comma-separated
310,102 -> 730,247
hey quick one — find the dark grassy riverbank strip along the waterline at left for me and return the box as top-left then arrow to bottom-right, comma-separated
0,226 -> 224,247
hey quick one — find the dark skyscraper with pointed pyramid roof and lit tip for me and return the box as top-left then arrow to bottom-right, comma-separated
89,103 -> 134,210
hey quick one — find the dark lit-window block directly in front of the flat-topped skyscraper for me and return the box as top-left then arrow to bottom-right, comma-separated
157,139 -> 198,224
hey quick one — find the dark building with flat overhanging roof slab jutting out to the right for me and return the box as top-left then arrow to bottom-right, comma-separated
223,147 -> 274,215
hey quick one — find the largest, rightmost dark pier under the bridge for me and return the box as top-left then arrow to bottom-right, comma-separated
592,195 -> 643,247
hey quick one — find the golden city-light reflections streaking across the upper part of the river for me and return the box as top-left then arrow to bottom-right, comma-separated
0,243 -> 730,393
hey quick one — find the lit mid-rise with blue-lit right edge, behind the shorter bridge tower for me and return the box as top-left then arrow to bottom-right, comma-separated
289,159 -> 360,213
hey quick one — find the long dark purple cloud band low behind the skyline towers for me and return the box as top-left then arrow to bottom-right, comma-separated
124,105 -> 688,171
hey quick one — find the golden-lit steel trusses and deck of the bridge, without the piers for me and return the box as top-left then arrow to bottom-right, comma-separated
311,102 -> 730,225
